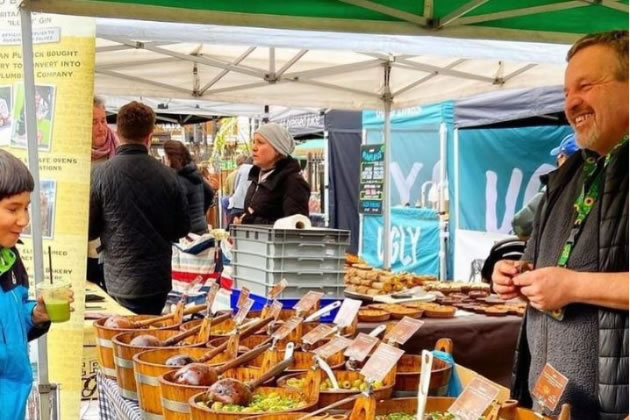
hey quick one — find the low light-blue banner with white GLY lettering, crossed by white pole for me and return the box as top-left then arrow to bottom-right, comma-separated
361,207 -> 440,275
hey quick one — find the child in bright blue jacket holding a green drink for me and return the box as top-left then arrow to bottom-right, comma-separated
0,150 -> 59,420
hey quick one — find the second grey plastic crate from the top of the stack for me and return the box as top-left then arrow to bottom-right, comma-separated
232,250 -> 345,272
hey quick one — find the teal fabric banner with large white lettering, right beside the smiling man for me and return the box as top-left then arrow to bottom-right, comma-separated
449,126 -> 571,234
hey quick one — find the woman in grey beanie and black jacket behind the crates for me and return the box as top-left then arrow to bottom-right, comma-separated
233,123 -> 311,225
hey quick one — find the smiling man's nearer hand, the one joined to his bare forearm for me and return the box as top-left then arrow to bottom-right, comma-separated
512,267 -> 575,311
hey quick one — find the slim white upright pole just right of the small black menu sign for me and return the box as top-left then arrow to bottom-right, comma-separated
383,62 -> 393,270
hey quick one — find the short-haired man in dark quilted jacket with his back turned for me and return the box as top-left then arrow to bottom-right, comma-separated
90,101 -> 190,314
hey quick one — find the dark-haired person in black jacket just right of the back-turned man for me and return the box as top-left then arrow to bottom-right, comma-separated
164,140 -> 214,235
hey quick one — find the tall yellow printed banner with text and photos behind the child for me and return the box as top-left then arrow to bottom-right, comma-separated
0,5 -> 95,419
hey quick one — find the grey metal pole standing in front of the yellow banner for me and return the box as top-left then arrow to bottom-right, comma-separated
20,7 -> 51,420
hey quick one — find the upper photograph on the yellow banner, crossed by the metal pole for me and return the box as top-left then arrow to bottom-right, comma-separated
11,83 -> 56,152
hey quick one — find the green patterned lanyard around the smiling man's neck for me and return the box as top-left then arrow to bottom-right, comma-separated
549,136 -> 628,321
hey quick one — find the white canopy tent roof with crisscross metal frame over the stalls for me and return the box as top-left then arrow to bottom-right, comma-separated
95,19 -> 568,110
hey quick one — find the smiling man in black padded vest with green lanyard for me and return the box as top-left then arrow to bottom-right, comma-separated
492,31 -> 628,420
